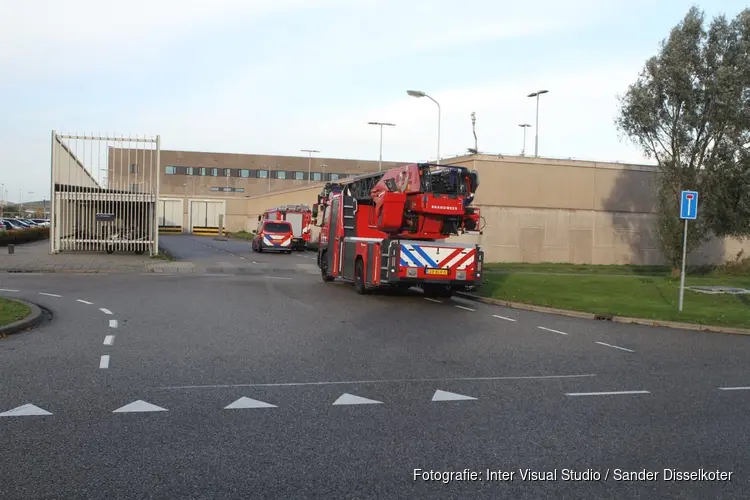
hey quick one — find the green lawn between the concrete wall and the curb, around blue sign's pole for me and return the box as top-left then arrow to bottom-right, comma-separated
479,272 -> 750,328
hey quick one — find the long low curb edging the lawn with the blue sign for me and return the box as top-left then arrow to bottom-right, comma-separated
455,292 -> 750,335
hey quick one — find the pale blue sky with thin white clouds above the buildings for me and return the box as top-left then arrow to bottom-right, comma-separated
0,0 -> 744,202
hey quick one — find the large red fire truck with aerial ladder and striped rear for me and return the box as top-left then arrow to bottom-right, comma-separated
312,163 -> 484,297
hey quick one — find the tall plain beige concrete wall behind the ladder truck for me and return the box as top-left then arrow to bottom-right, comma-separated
175,155 -> 750,264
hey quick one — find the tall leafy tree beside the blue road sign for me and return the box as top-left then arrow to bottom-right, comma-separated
616,7 -> 750,267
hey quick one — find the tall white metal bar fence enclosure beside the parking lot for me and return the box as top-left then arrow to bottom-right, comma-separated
50,130 -> 161,255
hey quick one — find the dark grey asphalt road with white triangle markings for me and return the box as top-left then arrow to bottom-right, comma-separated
0,239 -> 750,500
